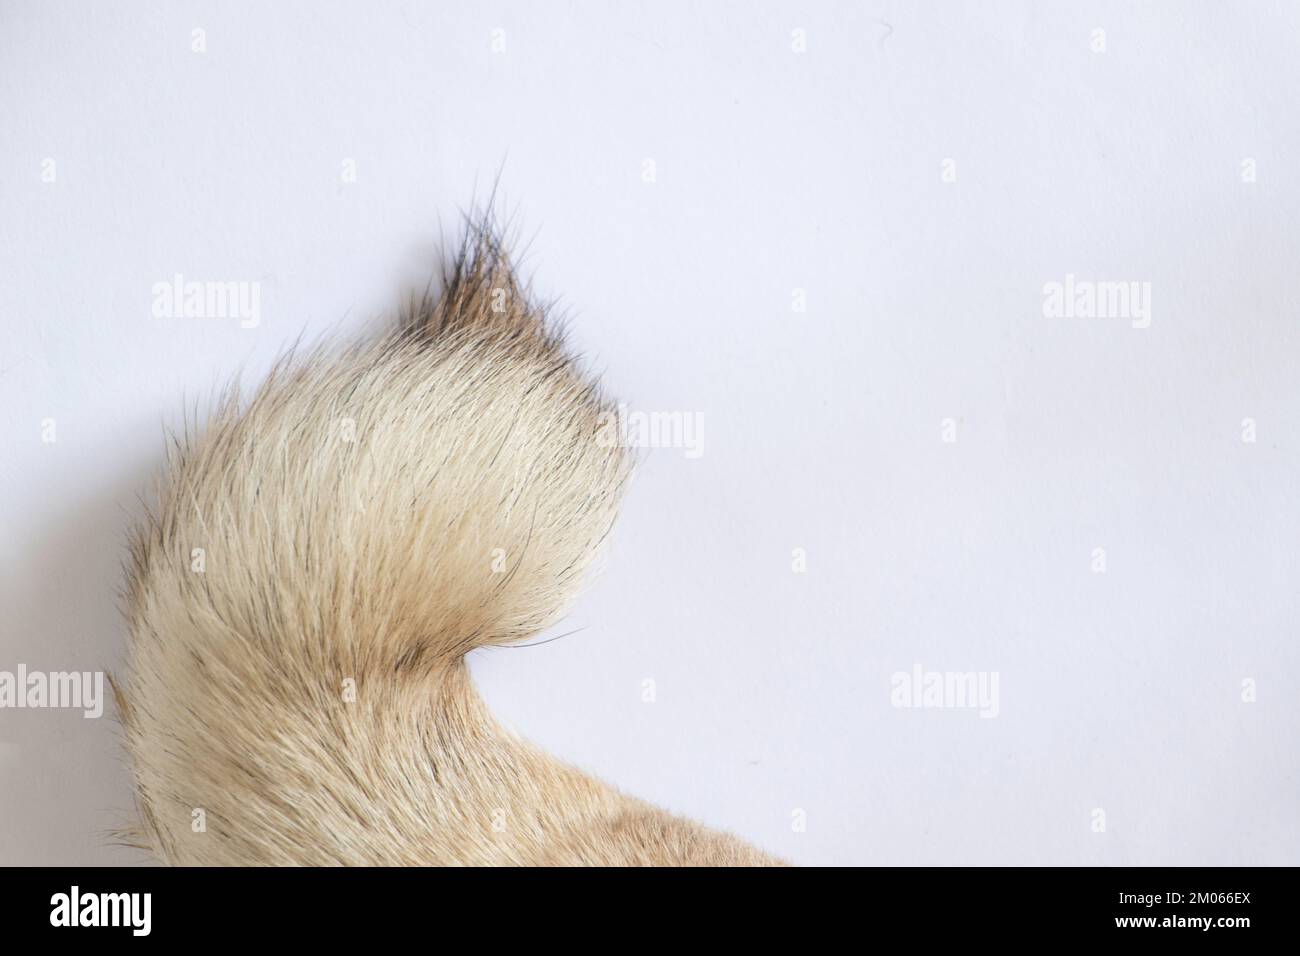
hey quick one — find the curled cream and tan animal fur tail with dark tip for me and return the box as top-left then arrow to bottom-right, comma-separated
118,222 -> 777,865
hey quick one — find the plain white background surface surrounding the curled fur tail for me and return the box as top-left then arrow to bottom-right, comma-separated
0,0 -> 1300,864
